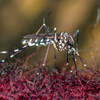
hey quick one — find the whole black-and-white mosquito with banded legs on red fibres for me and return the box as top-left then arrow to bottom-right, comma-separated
0,16 -> 93,75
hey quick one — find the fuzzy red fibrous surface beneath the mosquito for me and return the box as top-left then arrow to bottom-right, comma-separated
0,64 -> 100,100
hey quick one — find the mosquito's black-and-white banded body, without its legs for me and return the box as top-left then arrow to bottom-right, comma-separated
22,32 -> 74,52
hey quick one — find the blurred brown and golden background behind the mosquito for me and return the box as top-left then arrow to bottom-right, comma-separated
0,0 -> 100,69
